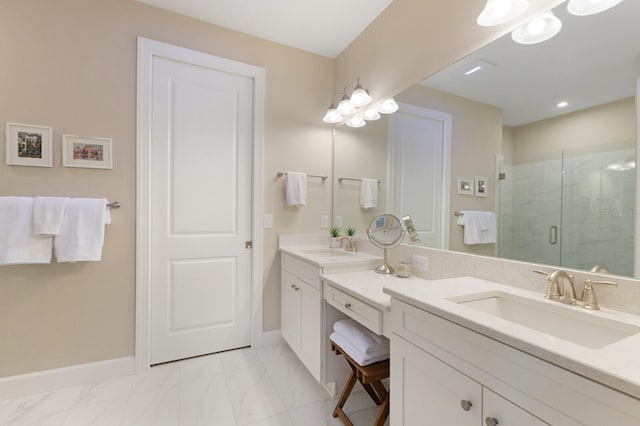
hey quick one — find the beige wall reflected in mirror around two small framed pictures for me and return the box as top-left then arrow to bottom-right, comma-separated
396,85 -> 502,256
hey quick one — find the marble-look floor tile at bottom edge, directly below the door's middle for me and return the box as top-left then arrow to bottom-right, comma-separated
180,373 -> 236,426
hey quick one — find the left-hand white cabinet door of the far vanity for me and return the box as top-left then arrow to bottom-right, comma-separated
280,270 -> 300,354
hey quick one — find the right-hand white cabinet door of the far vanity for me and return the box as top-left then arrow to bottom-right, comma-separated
298,281 -> 322,381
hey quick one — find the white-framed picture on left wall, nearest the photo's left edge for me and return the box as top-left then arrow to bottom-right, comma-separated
5,123 -> 53,167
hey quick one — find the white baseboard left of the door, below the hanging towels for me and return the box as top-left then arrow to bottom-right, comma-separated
0,356 -> 135,401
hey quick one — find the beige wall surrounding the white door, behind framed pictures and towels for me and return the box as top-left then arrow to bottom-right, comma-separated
0,0 -> 334,377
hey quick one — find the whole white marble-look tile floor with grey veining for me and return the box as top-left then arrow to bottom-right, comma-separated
0,345 -> 388,426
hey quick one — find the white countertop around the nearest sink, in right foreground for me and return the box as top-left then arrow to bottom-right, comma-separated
382,277 -> 640,399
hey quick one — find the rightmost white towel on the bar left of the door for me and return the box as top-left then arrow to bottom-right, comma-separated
54,198 -> 111,262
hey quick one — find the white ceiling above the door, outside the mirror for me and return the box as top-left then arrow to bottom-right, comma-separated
138,0 -> 393,58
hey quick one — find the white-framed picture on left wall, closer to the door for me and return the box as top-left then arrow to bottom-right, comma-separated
62,135 -> 113,169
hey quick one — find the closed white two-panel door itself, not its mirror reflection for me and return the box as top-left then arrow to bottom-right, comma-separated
150,43 -> 254,364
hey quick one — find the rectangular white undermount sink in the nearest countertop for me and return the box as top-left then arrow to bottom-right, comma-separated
449,291 -> 640,349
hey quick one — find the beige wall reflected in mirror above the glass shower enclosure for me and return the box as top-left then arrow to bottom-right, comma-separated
513,98 -> 636,162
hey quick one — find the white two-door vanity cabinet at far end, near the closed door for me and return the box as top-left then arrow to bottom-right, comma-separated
280,255 -> 322,382
